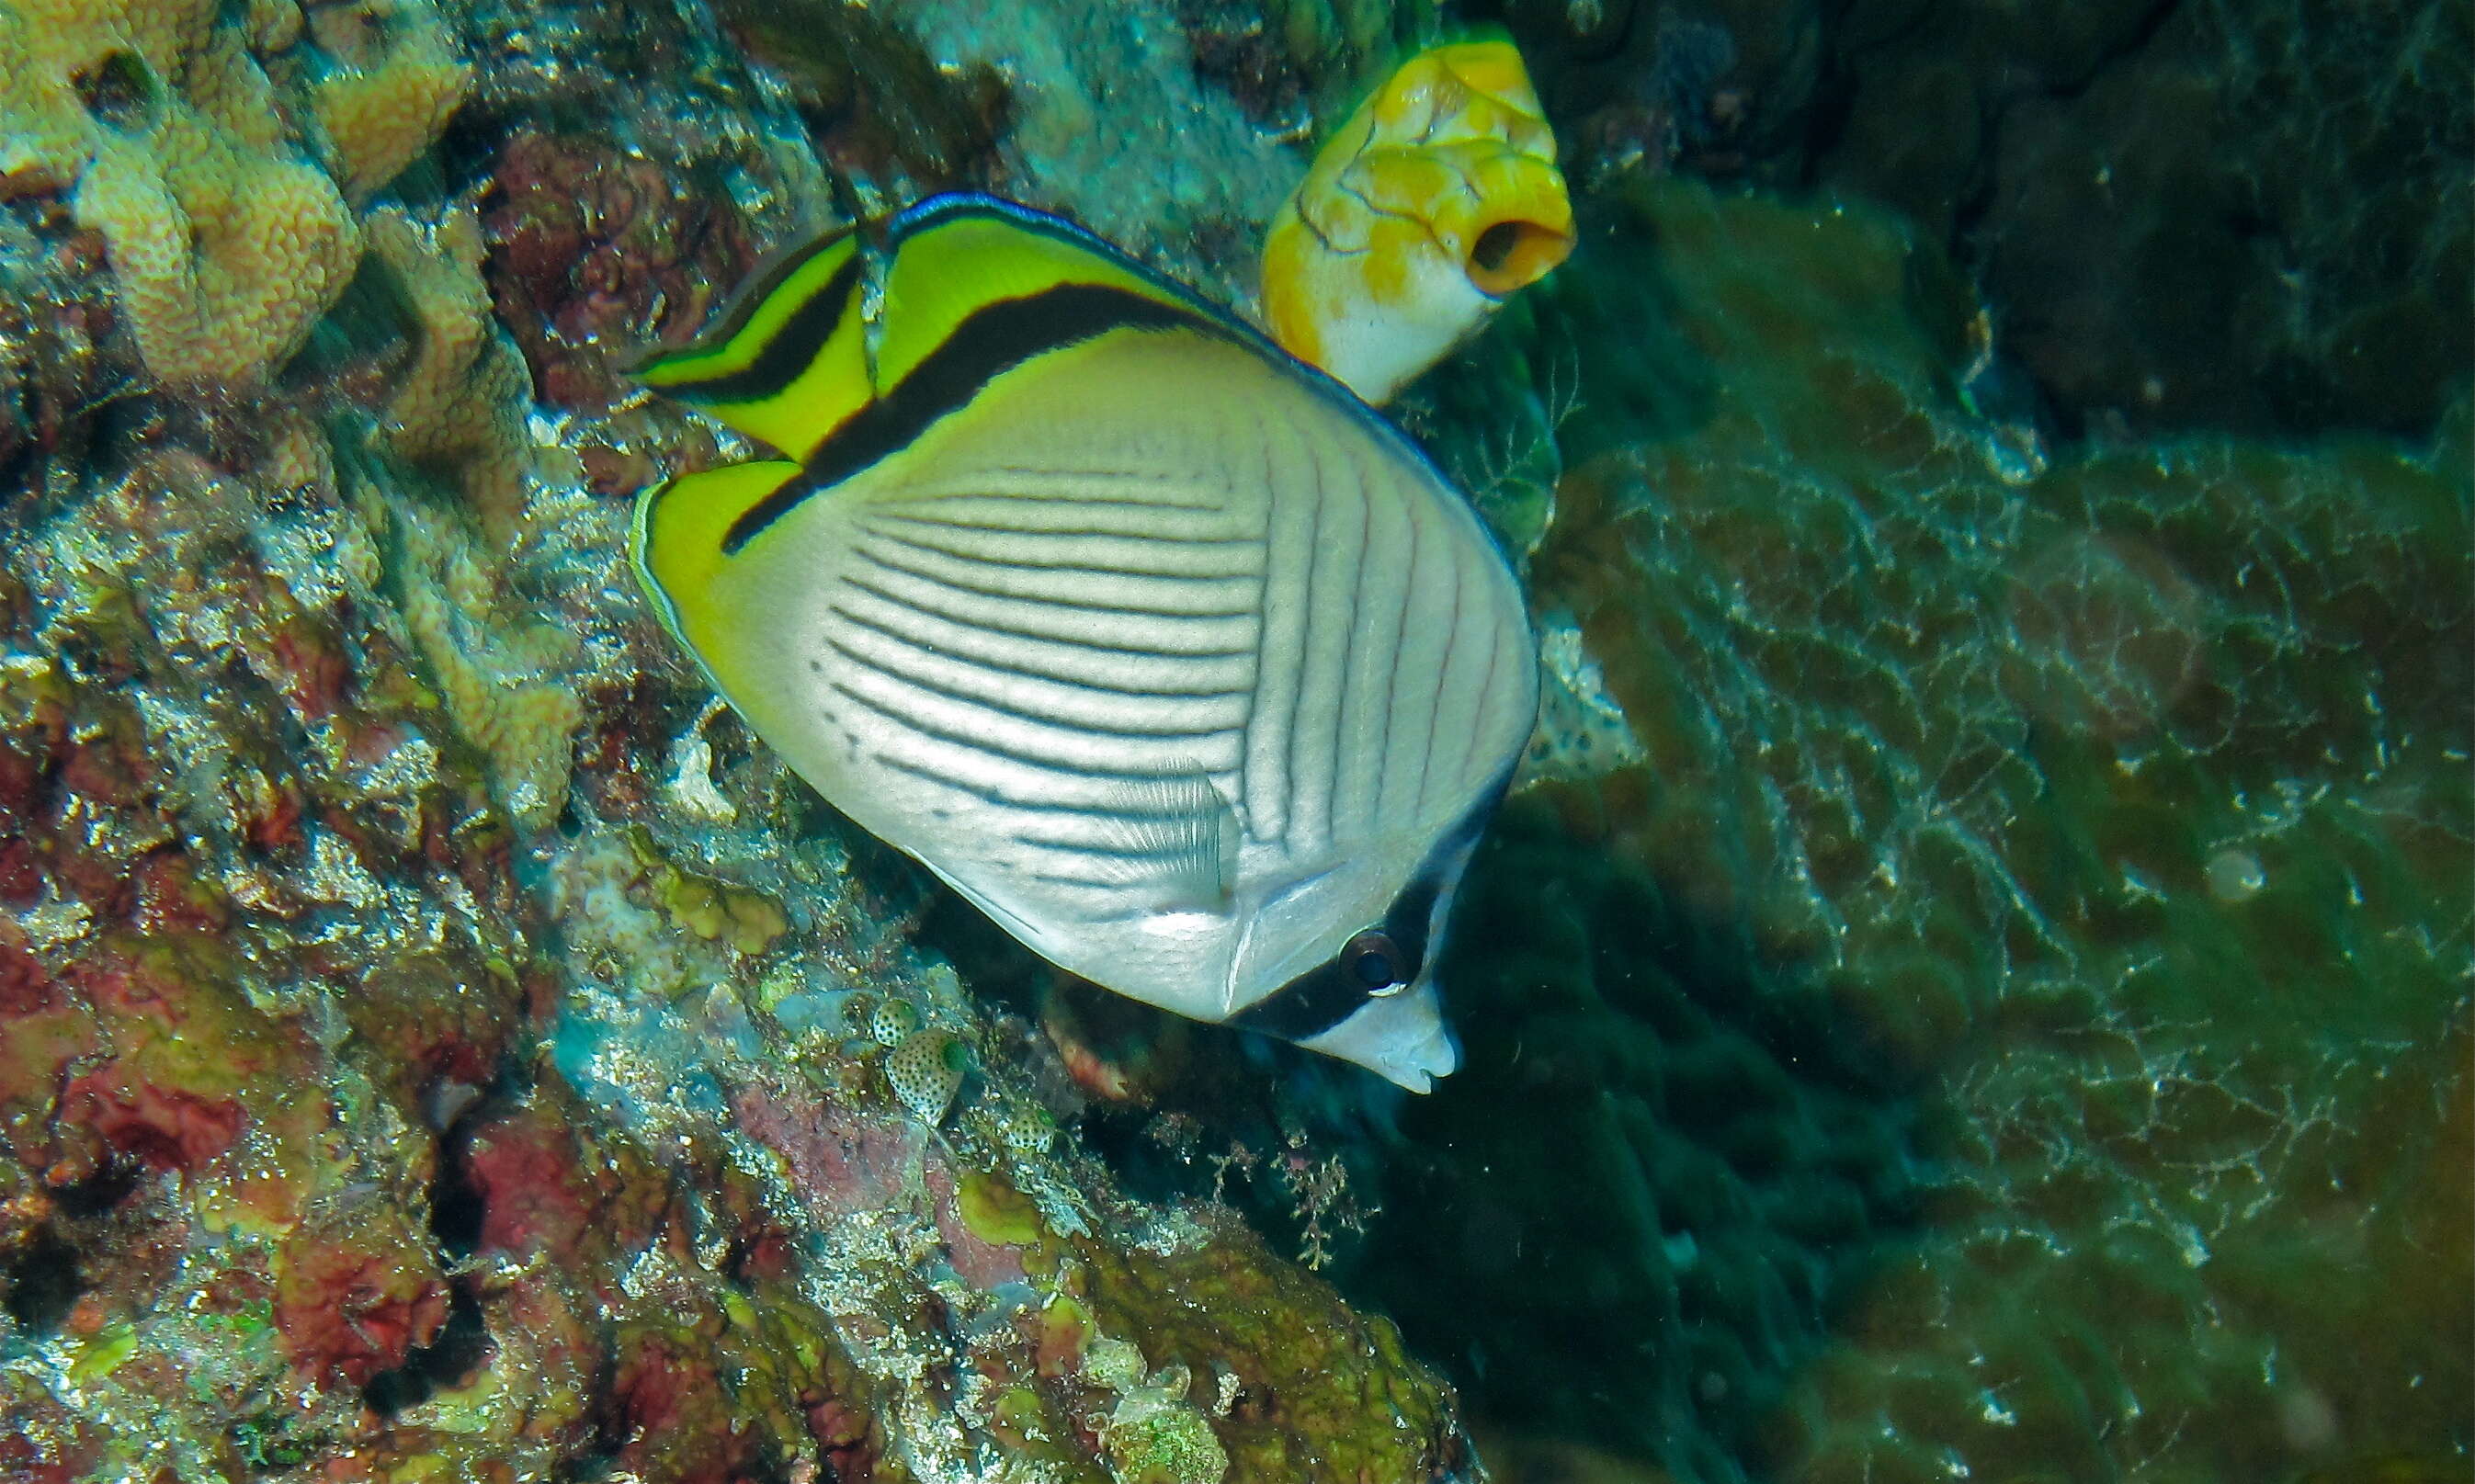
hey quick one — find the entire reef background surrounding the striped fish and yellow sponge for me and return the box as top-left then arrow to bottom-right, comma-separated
0,0 -> 2475,1484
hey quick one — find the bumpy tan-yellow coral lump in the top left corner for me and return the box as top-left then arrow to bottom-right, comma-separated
0,0 -> 471,396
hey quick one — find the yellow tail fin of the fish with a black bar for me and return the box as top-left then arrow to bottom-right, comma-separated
636,230 -> 869,458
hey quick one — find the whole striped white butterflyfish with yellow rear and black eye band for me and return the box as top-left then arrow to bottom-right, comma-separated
631,196 -> 1537,1091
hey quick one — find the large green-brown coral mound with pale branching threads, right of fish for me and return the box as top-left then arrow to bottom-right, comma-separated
1389,183 -> 2475,1481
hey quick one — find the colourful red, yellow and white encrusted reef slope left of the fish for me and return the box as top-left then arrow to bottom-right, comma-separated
0,0 -> 1475,1484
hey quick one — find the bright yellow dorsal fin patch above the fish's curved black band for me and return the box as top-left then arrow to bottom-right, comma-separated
876,196 -> 1220,396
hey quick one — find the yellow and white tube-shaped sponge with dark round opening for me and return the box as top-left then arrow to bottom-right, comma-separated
1262,42 -> 1572,403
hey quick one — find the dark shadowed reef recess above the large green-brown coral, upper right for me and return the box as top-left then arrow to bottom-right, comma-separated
1503,0 -> 2475,436
